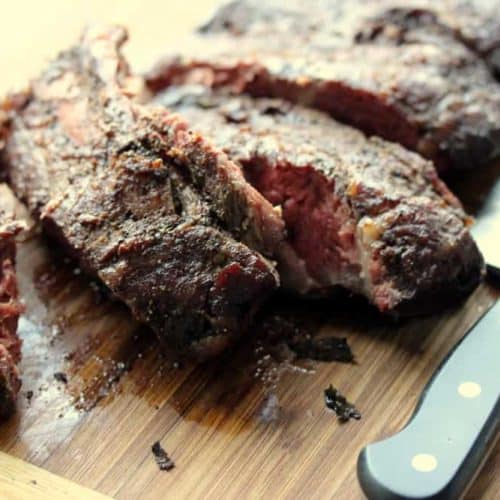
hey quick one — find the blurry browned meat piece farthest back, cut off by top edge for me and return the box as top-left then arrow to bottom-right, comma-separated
200,0 -> 500,78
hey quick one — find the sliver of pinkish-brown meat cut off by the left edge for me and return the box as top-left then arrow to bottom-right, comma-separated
0,210 -> 22,421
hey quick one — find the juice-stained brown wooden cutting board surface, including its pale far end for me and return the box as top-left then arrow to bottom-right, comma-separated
0,1 -> 500,500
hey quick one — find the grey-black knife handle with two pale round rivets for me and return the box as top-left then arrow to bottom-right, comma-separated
358,301 -> 500,500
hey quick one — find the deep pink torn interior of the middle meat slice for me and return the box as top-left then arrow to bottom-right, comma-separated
244,161 -> 360,289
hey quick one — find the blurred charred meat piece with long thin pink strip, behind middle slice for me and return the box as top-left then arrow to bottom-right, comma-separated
149,2 -> 500,169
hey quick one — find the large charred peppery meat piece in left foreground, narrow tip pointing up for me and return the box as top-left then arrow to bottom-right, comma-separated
4,27 -> 284,355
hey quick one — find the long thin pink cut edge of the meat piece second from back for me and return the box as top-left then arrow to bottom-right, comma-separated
148,62 -> 422,159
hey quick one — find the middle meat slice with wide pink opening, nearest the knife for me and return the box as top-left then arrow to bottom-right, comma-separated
155,86 -> 483,314
